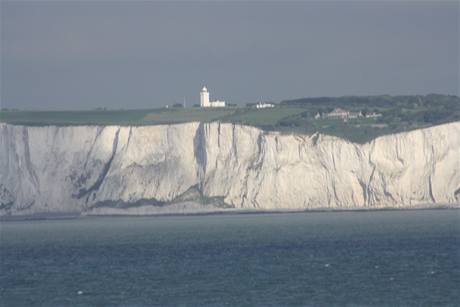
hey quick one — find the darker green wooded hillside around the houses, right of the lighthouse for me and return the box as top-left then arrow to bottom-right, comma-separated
279,94 -> 460,143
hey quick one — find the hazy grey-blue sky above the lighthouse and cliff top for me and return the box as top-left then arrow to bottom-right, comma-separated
1,1 -> 459,109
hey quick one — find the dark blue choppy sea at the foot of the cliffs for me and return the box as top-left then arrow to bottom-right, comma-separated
0,210 -> 460,306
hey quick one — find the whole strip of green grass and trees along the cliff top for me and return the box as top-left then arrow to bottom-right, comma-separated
0,94 -> 460,143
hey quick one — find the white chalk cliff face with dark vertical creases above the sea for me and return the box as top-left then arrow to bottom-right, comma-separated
0,123 -> 460,215
